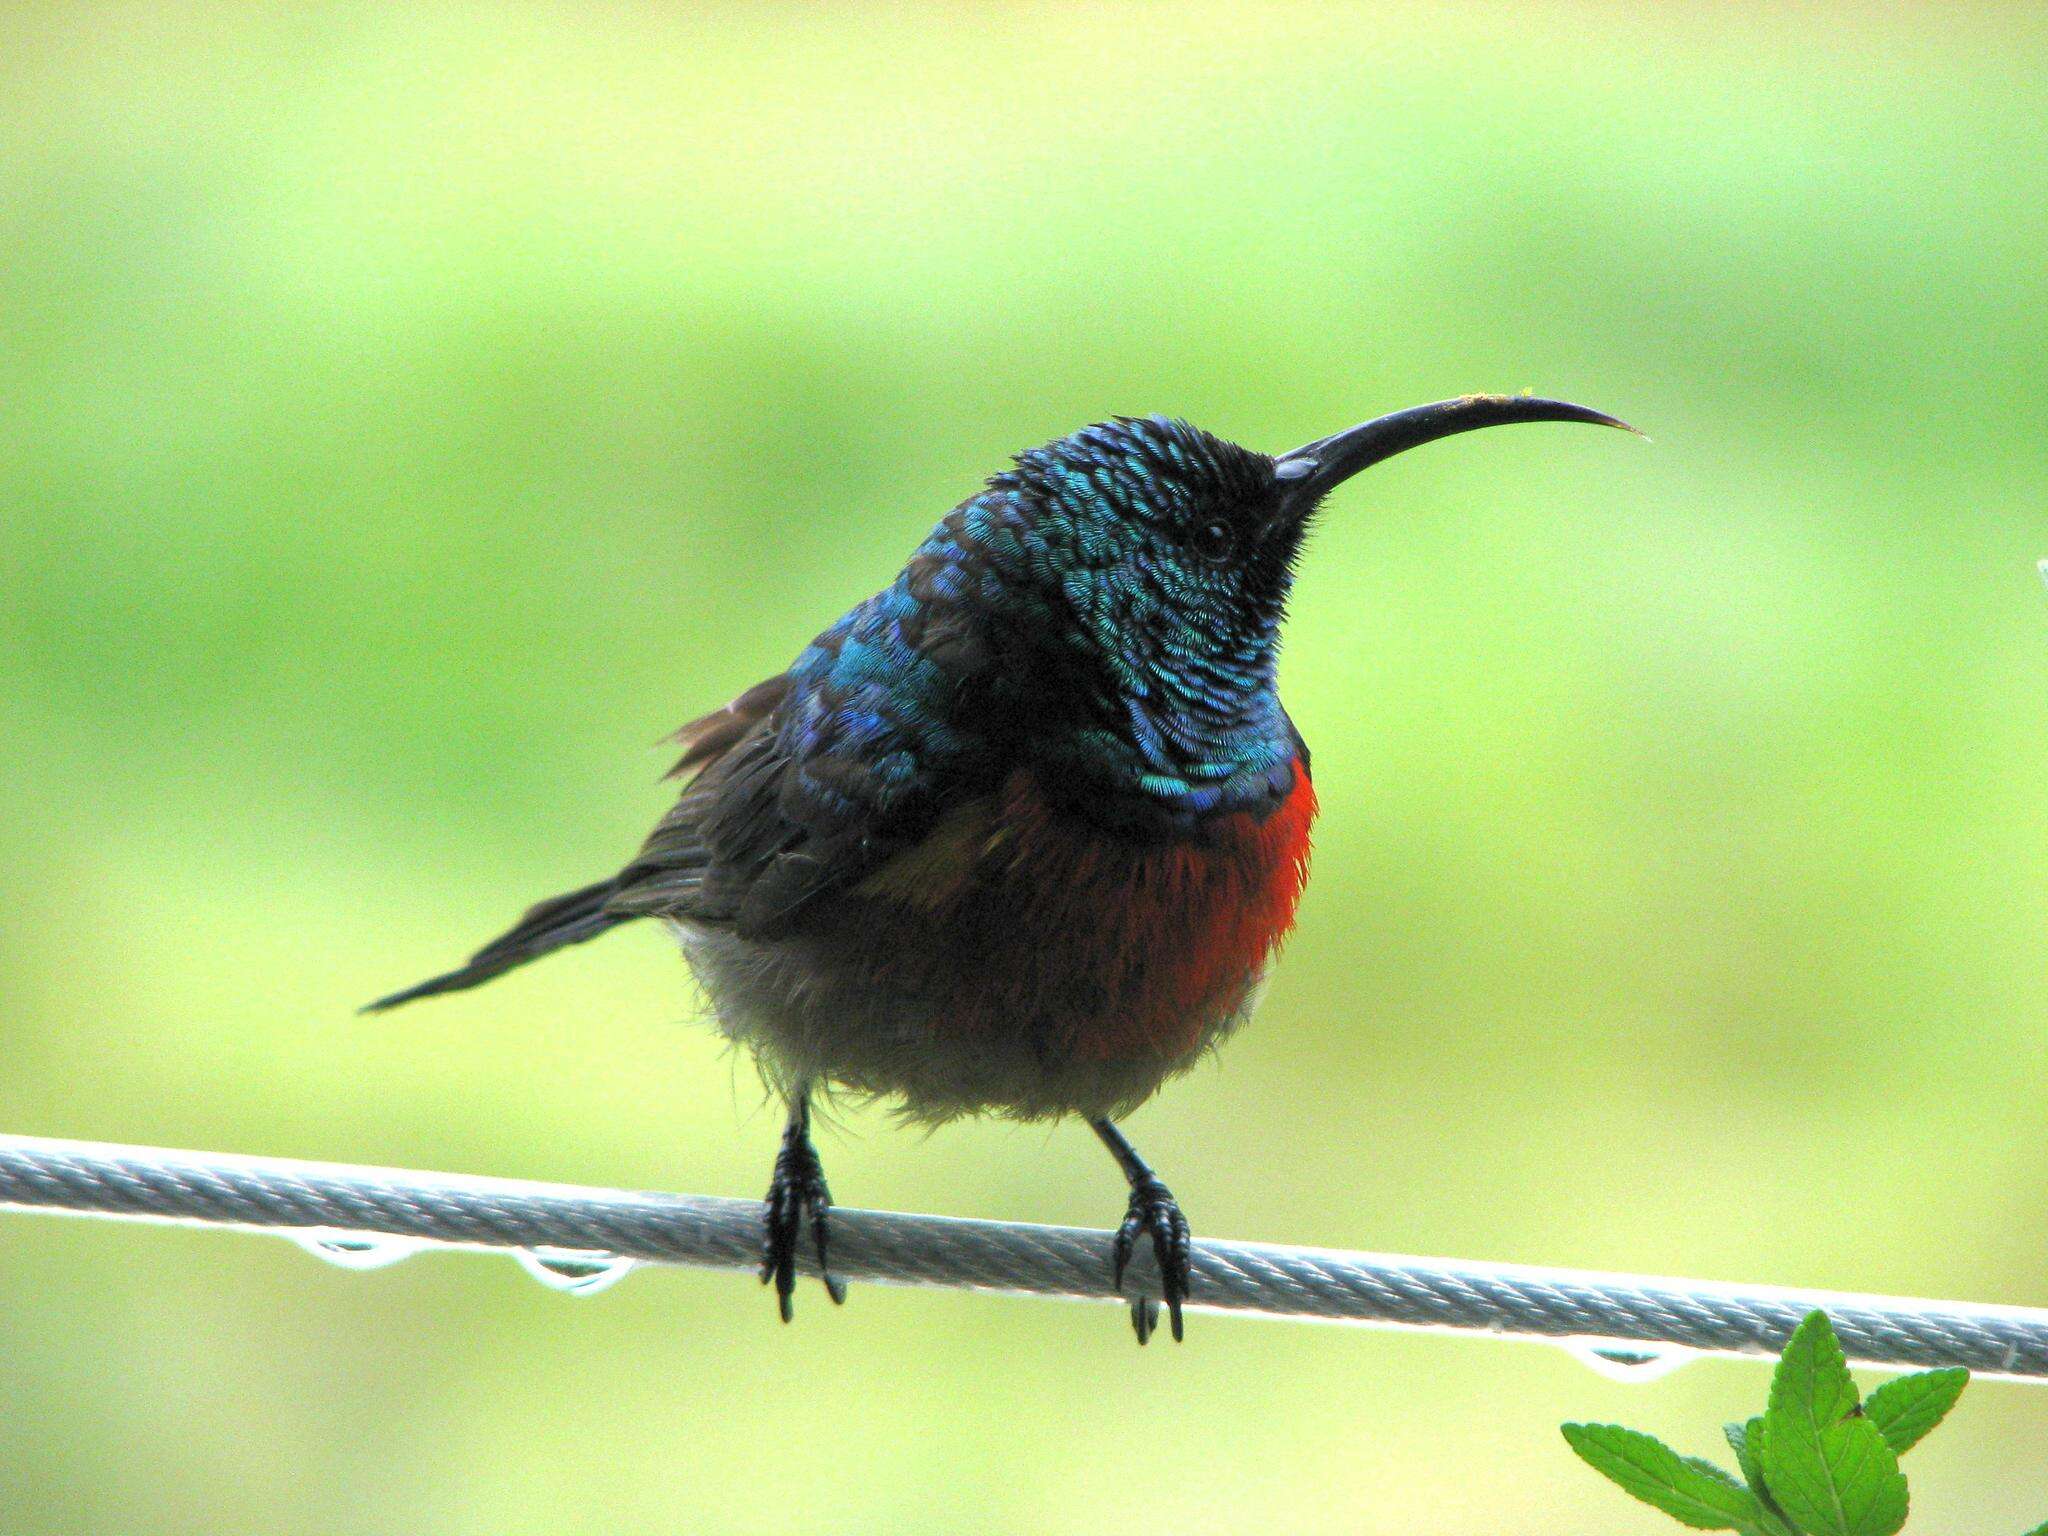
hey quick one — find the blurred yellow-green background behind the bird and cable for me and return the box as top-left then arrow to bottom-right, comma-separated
0,4 -> 2048,1536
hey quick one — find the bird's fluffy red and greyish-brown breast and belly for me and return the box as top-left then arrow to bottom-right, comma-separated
667,766 -> 1315,1120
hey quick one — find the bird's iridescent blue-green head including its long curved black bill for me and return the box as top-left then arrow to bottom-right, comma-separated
954,395 -> 1622,819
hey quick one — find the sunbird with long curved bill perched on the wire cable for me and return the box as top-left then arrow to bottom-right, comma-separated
365,395 -> 1634,1343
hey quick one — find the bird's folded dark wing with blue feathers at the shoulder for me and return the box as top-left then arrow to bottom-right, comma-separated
606,610 -> 985,938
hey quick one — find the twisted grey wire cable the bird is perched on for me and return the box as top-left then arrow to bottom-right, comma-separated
0,1137 -> 2048,1380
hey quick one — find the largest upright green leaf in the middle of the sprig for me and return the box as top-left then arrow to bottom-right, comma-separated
1757,1313 -> 1907,1536
